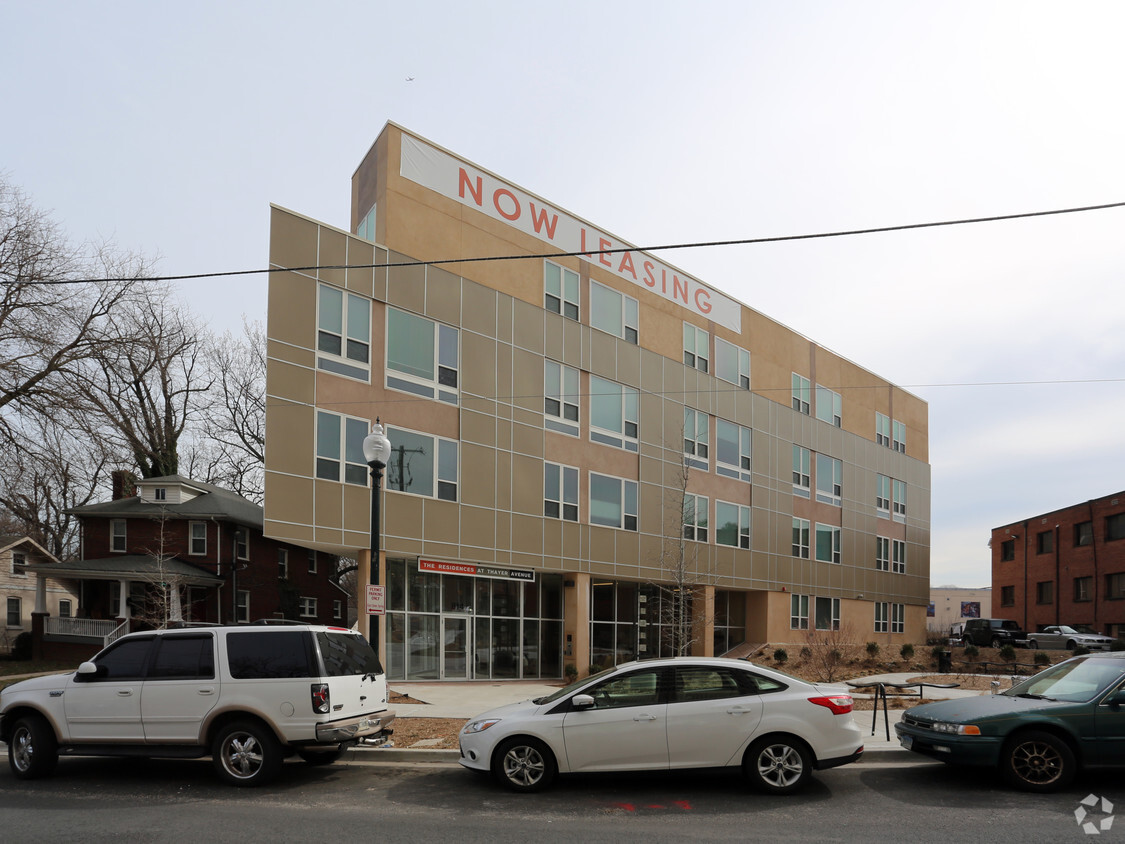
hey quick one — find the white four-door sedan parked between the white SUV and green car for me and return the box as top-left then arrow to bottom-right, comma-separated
459,657 -> 863,793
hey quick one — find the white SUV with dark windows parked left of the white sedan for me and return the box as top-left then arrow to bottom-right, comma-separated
0,623 -> 395,785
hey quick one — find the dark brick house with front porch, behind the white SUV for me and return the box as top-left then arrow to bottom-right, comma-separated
27,473 -> 348,658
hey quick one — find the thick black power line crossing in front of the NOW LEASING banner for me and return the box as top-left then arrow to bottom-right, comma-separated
6,203 -> 1125,285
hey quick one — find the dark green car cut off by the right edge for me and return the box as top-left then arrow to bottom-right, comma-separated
894,653 -> 1125,792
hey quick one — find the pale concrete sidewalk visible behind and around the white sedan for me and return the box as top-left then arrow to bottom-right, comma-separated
360,672 -> 1006,764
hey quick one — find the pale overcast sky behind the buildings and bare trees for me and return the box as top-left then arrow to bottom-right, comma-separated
0,0 -> 1125,586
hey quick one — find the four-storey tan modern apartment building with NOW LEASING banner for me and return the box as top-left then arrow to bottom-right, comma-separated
266,124 -> 930,680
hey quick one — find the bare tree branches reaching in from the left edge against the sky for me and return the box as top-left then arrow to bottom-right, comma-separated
0,177 -> 147,445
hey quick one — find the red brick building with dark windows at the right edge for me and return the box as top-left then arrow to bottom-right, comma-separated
991,492 -> 1125,638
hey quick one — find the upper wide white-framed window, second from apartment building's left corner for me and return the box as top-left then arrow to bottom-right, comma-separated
387,307 -> 460,404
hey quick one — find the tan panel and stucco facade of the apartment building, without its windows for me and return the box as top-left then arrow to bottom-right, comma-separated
266,124 -> 930,670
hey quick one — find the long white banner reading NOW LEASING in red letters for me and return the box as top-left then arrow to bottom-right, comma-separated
401,134 -> 743,332
